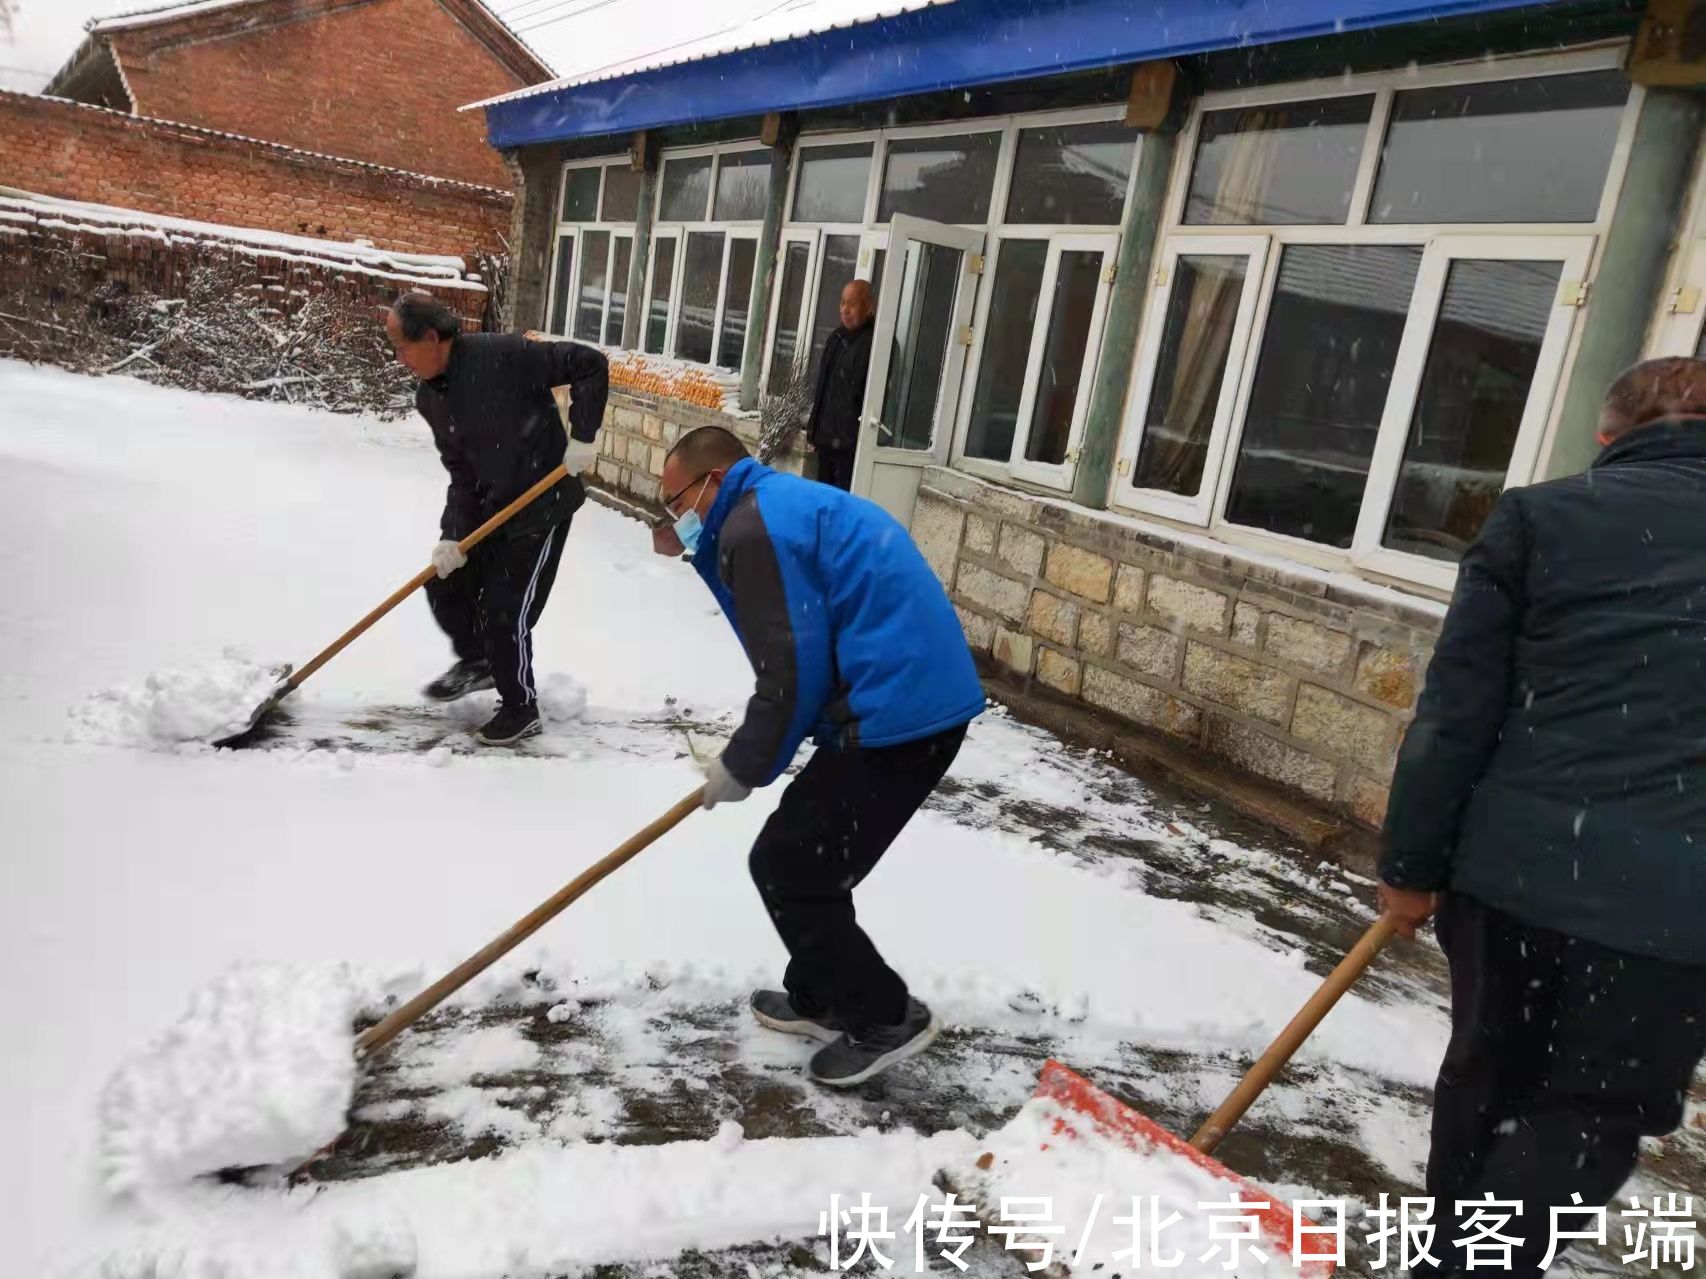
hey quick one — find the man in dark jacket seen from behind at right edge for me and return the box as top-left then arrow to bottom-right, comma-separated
1380,360 -> 1706,1276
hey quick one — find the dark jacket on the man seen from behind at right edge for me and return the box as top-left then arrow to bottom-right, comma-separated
1380,420 -> 1706,964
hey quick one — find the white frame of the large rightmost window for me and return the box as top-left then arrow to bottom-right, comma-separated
1109,41 -> 1645,590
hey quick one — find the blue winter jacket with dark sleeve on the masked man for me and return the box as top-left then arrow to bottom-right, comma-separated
693,459 -> 984,786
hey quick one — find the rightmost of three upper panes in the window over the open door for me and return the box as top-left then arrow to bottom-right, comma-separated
1007,119 -> 1138,227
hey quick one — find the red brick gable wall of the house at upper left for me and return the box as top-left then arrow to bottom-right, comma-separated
107,0 -> 529,188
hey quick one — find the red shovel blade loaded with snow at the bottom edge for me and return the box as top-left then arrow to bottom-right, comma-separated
950,1061 -> 1334,1279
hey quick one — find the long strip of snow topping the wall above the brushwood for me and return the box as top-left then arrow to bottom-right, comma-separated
0,193 -> 486,293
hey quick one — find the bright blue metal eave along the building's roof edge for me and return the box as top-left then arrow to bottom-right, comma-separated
486,0 -> 1562,148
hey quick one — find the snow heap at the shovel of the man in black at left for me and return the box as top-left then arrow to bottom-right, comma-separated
67,648 -> 280,745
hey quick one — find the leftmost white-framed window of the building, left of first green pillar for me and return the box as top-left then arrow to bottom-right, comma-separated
546,160 -> 640,346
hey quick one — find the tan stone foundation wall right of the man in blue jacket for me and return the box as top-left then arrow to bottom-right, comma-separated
913,469 -> 1443,825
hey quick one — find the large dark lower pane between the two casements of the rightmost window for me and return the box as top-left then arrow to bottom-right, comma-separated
1227,244 -> 1421,547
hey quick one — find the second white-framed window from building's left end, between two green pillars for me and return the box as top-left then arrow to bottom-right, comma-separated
643,147 -> 771,370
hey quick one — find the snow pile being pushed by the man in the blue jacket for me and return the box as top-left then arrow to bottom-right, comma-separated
101,964 -> 360,1194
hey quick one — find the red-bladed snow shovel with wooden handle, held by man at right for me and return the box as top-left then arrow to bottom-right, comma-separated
979,914 -> 1396,1279
